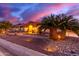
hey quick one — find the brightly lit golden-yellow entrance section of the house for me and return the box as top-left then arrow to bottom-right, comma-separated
24,21 -> 39,34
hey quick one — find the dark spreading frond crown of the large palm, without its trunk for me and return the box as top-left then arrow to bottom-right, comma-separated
41,14 -> 79,34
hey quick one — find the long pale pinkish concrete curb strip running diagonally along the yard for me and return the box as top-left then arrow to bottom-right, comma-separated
0,39 -> 46,56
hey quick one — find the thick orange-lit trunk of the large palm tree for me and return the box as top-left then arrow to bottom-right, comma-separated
50,28 -> 66,40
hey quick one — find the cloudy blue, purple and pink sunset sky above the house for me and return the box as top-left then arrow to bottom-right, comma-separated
0,3 -> 79,23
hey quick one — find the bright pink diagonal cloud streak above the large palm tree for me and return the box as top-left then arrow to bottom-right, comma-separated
31,4 -> 75,21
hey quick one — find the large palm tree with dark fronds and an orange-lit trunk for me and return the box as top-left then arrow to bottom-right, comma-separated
39,14 -> 79,40
